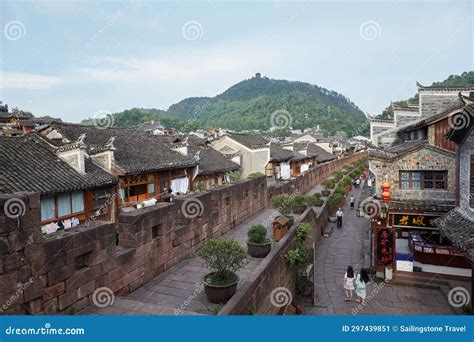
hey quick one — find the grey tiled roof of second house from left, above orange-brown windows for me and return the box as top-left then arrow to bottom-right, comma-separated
48,123 -> 196,174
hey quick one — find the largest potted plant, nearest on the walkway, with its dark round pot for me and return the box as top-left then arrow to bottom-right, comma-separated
198,239 -> 247,303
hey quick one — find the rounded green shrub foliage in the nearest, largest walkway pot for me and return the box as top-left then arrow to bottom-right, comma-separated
198,239 -> 247,285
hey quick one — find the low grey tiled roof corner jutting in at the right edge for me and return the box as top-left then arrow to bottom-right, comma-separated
434,208 -> 474,260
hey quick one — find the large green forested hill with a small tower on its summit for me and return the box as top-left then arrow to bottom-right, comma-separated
82,77 -> 366,135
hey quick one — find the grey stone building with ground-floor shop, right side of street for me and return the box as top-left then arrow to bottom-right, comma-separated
369,87 -> 474,278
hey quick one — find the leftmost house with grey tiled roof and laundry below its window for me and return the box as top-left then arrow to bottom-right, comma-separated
0,132 -> 118,233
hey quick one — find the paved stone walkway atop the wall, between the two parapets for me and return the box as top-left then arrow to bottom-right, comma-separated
81,209 -> 275,315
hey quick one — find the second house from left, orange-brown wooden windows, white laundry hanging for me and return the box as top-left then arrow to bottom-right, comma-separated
42,123 -> 197,206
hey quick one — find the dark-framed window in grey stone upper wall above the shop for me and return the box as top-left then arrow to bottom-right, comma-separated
400,171 -> 448,190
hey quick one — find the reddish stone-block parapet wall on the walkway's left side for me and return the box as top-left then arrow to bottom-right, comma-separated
0,153 -> 365,315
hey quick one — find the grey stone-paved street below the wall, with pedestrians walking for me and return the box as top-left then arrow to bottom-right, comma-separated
305,184 -> 454,315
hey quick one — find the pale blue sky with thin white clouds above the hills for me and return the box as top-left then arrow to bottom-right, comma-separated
0,0 -> 474,122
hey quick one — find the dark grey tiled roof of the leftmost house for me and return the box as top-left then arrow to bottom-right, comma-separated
0,132 -> 117,194
